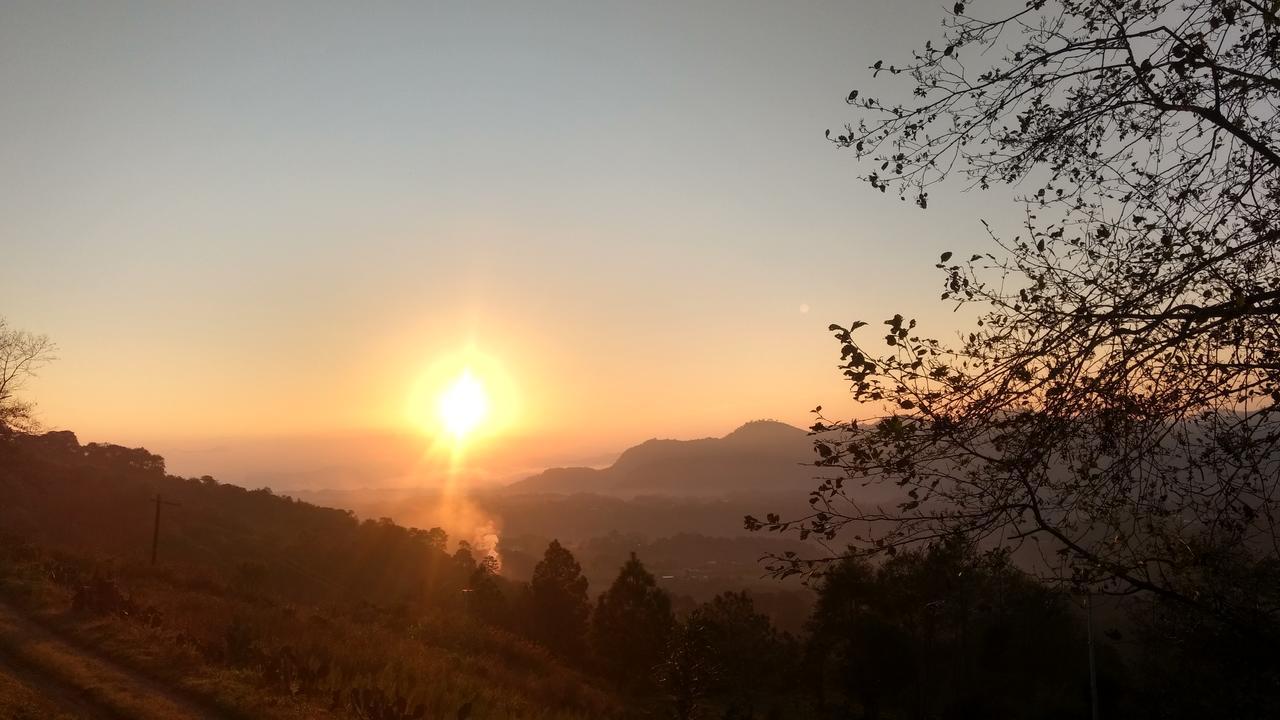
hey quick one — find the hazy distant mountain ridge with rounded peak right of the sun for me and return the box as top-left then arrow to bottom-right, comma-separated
507,420 -> 819,496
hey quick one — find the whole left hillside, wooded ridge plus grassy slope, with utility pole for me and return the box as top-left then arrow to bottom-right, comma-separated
0,433 -> 626,720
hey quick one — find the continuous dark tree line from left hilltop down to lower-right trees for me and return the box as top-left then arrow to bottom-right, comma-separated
0,422 -> 1129,719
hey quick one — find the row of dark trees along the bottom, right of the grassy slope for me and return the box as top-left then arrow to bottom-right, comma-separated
483,525 -> 1116,719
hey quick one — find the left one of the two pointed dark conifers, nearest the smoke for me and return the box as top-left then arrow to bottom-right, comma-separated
529,539 -> 591,659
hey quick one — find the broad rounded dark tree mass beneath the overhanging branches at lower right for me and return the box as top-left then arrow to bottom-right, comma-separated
810,538 -> 1095,719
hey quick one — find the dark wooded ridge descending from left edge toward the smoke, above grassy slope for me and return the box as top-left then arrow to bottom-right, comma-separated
0,432 -> 467,602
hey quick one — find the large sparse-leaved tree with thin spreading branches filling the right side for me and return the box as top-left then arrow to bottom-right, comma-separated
748,0 -> 1280,639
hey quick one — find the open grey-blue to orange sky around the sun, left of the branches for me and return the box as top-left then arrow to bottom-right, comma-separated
0,0 -> 1011,484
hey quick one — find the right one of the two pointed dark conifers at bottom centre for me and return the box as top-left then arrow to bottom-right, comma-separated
591,552 -> 675,691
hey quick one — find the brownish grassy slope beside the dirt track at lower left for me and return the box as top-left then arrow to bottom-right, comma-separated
0,543 -> 623,720
